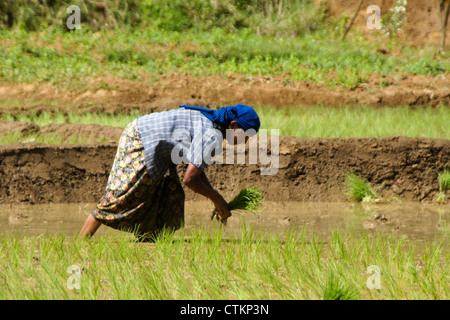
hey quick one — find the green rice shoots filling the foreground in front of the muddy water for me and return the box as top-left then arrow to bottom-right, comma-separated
0,226 -> 450,300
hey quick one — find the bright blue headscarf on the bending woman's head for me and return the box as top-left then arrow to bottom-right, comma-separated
180,104 -> 261,132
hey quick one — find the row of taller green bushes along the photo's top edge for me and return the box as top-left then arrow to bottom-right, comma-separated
0,0 -> 323,36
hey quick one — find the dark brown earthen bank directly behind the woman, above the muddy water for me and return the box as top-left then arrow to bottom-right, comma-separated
0,137 -> 450,203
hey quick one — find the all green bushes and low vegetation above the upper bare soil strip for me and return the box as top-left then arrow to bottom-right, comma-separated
0,0 -> 450,90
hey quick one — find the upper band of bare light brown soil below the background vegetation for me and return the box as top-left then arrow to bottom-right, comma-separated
0,74 -> 450,113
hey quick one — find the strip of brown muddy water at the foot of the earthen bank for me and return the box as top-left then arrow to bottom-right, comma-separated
0,201 -> 450,241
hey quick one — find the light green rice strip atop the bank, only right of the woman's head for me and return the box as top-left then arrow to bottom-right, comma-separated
255,105 -> 450,139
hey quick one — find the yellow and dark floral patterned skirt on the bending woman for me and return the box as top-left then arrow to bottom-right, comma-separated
92,120 -> 185,239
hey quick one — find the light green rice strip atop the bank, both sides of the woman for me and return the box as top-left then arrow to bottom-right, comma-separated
0,102 -> 450,139
